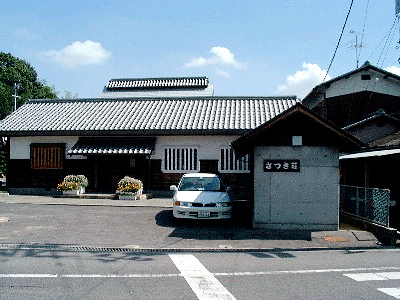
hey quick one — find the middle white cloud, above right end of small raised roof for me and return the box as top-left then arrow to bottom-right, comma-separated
185,47 -> 245,69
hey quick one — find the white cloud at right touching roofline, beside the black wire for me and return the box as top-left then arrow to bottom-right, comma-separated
277,63 -> 330,98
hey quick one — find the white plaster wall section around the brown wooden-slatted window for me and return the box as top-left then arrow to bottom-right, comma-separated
10,136 -> 86,159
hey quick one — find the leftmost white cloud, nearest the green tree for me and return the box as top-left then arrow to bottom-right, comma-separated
45,40 -> 111,68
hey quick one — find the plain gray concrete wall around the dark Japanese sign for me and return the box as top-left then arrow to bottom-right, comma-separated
253,147 -> 339,230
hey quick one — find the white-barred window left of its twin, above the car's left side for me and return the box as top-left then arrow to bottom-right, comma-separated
164,148 -> 199,172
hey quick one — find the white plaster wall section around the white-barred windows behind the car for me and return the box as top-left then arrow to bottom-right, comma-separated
151,135 -> 239,159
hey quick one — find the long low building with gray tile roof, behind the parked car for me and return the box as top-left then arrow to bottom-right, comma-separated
0,77 -> 298,193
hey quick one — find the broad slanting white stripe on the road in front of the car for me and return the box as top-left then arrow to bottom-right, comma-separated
169,254 -> 235,300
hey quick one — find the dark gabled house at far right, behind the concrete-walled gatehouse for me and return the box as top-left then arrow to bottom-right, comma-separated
302,62 -> 400,228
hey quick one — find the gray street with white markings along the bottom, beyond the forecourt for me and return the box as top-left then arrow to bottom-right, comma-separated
0,248 -> 400,300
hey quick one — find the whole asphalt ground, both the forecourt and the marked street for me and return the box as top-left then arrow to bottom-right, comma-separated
0,203 -> 400,300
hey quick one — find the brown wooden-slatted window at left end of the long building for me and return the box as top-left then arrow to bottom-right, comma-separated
31,144 -> 65,170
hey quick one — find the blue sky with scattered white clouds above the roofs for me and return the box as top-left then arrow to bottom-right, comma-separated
0,0 -> 400,98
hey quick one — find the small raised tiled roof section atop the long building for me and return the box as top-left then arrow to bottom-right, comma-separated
102,77 -> 214,97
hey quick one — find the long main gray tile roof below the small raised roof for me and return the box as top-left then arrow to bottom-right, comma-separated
0,96 -> 297,136
